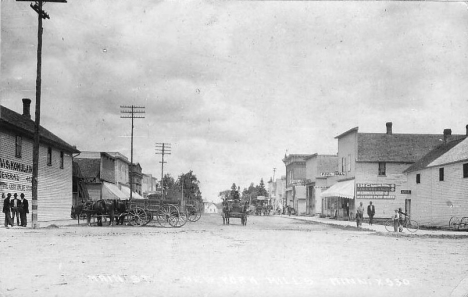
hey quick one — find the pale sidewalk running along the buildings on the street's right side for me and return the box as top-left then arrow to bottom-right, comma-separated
281,215 -> 468,238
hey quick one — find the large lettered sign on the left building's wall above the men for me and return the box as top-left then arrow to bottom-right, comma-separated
0,158 -> 32,194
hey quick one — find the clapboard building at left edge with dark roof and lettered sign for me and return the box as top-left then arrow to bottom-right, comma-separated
0,99 -> 79,222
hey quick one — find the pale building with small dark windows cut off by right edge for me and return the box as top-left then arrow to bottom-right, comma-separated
405,127 -> 468,227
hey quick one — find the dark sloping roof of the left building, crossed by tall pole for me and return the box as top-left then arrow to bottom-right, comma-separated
0,105 -> 80,153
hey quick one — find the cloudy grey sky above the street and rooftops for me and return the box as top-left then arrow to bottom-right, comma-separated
0,0 -> 468,202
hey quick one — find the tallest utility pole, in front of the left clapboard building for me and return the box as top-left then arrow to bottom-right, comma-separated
16,0 -> 67,228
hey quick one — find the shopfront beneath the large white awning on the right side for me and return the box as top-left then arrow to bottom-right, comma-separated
321,179 -> 355,219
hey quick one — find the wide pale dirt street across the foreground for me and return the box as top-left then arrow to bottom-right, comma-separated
0,215 -> 468,297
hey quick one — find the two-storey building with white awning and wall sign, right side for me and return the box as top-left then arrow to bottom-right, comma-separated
322,123 -> 462,218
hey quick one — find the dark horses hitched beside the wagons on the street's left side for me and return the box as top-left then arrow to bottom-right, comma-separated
83,199 -> 126,226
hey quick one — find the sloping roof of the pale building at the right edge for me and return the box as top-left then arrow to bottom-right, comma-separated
404,138 -> 468,173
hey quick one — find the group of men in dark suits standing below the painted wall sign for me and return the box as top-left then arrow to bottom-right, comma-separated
2,193 -> 29,228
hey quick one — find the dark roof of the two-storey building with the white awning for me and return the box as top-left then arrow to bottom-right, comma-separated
357,133 -> 465,163
